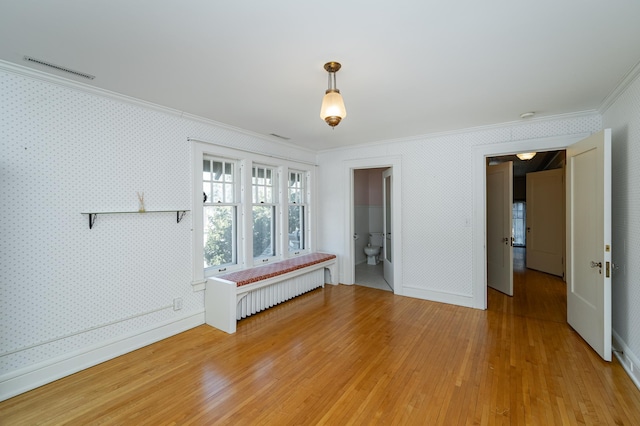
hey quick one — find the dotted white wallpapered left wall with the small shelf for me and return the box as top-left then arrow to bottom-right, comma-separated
0,68 -> 315,399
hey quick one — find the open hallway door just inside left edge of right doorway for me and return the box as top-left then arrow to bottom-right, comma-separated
487,161 -> 513,296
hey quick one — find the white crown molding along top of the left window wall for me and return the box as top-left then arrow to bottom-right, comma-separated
0,59 -> 317,155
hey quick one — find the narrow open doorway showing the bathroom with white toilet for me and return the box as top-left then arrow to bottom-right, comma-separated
352,167 -> 393,291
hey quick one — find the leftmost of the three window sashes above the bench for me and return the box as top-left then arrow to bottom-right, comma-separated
202,156 -> 239,271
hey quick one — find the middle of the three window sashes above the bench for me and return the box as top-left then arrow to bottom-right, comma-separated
251,166 -> 278,260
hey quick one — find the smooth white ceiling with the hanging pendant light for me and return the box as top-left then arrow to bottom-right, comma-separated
0,0 -> 640,150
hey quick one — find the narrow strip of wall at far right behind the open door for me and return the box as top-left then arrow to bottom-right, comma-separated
602,67 -> 640,387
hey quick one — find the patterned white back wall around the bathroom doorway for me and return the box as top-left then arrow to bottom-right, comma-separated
318,113 -> 602,306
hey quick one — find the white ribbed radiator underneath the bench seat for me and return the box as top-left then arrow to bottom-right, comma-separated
236,268 -> 324,320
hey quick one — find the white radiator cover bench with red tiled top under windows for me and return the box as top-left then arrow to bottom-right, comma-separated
205,253 -> 337,333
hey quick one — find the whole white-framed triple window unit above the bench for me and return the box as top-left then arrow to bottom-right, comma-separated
191,140 -> 316,282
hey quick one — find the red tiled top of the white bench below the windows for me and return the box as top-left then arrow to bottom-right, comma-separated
216,253 -> 336,287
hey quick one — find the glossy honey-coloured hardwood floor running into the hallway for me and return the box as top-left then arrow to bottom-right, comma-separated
0,269 -> 640,425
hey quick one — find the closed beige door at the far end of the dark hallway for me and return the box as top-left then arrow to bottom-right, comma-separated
526,169 -> 565,277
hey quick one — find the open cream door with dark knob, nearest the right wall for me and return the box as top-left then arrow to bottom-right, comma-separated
567,129 -> 611,361
